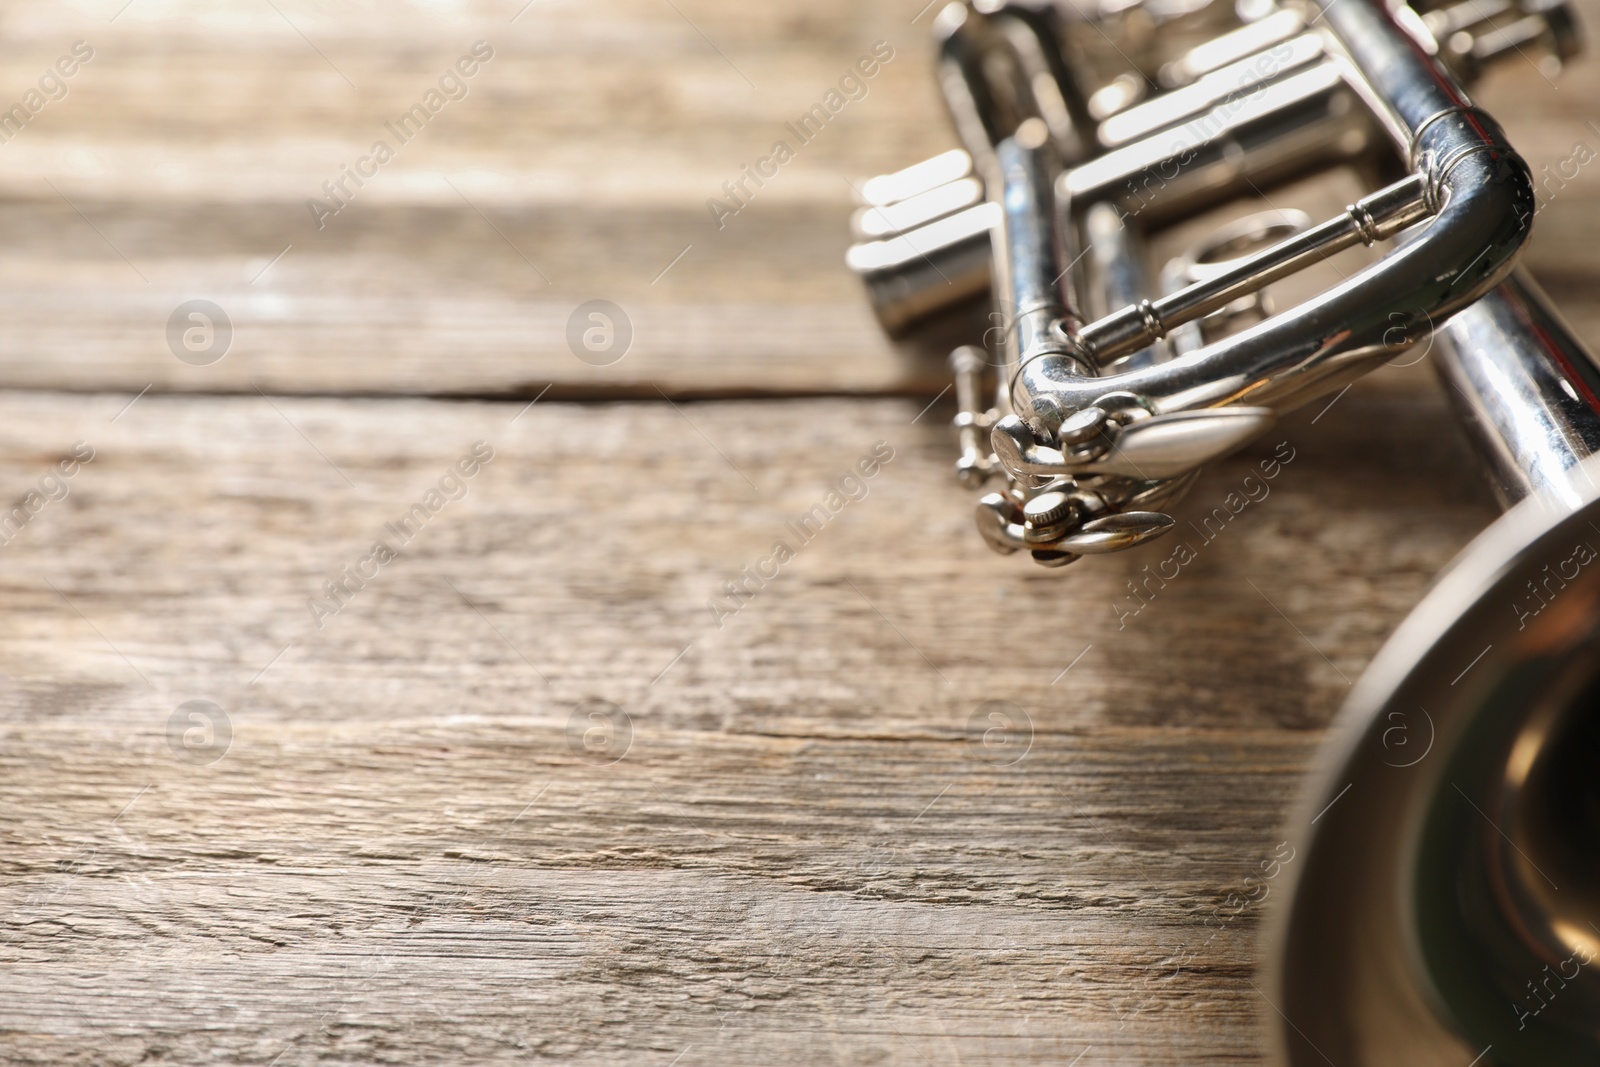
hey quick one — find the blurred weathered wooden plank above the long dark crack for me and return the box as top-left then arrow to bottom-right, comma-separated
0,0 -> 1600,397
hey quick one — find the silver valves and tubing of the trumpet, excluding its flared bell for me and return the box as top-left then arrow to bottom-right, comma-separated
848,0 -> 1576,566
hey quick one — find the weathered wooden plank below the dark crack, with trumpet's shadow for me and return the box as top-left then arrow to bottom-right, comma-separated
0,379 -> 1493,1065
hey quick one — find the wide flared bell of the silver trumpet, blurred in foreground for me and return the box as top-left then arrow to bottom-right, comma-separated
1267,458 -> 1600,1067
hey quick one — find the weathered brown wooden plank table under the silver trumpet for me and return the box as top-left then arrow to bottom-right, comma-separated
0,0 -> 1600,1067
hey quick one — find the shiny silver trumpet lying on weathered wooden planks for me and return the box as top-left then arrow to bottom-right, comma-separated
848,0 -> 1600,1067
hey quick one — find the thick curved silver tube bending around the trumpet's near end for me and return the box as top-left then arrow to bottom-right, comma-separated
1011,0 -> 1534,434
